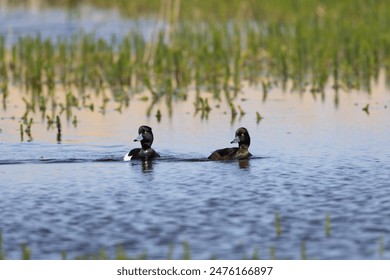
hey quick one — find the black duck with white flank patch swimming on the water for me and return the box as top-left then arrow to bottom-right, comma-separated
123,125 -> 160,161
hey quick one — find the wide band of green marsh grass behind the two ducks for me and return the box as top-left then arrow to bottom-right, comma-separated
0,0 -> 390,139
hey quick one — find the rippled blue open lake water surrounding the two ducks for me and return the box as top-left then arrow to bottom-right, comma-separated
0,4 -> 390,259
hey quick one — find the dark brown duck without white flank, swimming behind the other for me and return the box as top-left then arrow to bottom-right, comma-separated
208,127 -> 252,160
